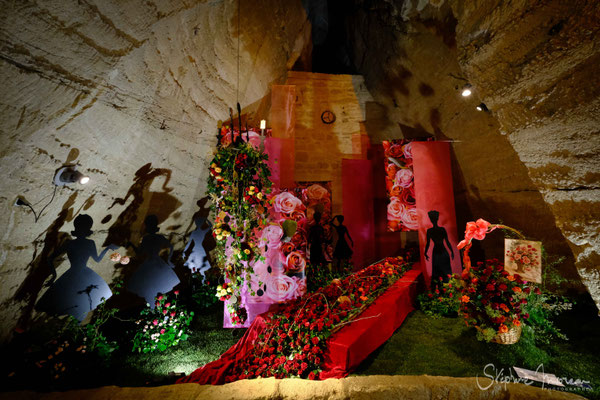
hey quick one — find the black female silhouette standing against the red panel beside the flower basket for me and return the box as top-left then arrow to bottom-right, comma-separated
425,210 -> 454,290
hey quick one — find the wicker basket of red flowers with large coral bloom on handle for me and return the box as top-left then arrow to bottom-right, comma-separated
458,219 -> 532,344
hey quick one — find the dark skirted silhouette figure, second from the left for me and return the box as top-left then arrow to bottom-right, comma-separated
127,215 -> 179,309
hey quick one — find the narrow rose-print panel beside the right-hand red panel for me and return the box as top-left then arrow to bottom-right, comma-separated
383,139 -> 419,232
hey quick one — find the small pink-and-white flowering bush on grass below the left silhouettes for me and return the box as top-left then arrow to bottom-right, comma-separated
133,290 -> 194,353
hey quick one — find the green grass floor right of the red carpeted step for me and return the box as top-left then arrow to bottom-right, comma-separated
354,311 -> 600,399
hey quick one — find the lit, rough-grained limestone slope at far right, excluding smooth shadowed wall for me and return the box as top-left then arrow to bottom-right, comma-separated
451,0 -> 600,308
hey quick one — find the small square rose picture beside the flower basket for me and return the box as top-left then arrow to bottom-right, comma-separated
504,239 -> 542,283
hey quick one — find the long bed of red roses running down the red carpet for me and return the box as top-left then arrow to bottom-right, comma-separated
220,257 -> 411,382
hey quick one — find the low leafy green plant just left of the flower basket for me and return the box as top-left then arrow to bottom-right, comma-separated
417,275 -> 462,318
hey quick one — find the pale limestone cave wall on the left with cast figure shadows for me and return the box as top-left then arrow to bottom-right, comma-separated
0,0 -> 310,339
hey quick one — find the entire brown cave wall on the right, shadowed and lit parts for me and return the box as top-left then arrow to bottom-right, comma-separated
347,0 -> 600,303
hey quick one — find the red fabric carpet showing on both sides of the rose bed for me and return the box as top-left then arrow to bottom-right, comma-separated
177,265 -> 421,385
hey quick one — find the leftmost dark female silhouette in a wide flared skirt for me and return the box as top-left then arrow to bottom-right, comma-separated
37,214 -> 119,321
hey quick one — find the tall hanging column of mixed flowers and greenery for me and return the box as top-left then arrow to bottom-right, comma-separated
207,127 -> 271,325
